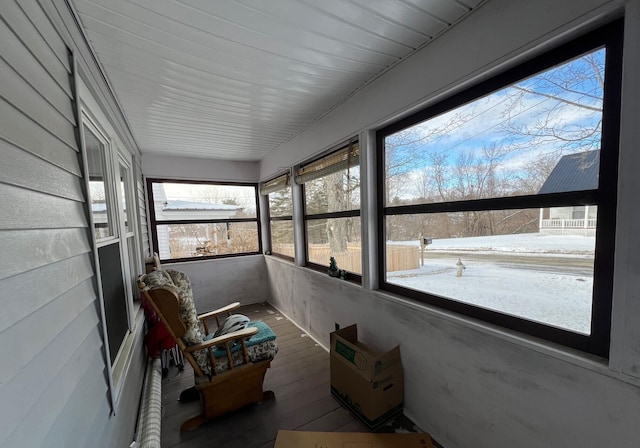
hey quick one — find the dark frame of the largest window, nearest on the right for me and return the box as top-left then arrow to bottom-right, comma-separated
376,20 -> 623,358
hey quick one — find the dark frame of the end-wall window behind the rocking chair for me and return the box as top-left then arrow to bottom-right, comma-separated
145,177 -> 262,263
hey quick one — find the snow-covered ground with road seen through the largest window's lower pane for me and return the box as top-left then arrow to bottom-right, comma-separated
387,233 -> 595,334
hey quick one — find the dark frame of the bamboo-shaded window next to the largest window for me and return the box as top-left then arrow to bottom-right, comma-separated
294,140 -> 364,283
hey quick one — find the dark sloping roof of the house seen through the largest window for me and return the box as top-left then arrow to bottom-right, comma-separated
538,149 -> 600,194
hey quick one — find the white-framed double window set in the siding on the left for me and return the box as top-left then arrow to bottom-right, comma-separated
81,111 -> 140,376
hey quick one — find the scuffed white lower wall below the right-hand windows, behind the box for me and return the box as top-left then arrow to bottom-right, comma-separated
266,257 -> 640,448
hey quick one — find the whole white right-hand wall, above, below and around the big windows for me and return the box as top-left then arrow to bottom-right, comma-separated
260,0 -> 640,448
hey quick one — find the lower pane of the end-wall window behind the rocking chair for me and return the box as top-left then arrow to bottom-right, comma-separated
157,222 -> 259,259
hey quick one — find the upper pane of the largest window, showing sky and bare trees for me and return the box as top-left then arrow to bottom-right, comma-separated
384,49 -> 605,206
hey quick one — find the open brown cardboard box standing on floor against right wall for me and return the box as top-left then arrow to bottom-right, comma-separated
329,325 -> 404,431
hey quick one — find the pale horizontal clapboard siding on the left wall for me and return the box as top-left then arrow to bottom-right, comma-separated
0,0 -> 144,447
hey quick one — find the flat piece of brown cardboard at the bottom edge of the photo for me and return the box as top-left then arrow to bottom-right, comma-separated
273,430 -> 433,448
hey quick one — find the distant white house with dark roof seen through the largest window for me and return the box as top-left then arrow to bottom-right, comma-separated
538,150 -> 600,236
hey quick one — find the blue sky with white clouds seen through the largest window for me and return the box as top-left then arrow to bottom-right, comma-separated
386,49 -> 605,198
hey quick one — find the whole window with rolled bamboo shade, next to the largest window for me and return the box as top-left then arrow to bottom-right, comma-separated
295,141 -> 362,279
